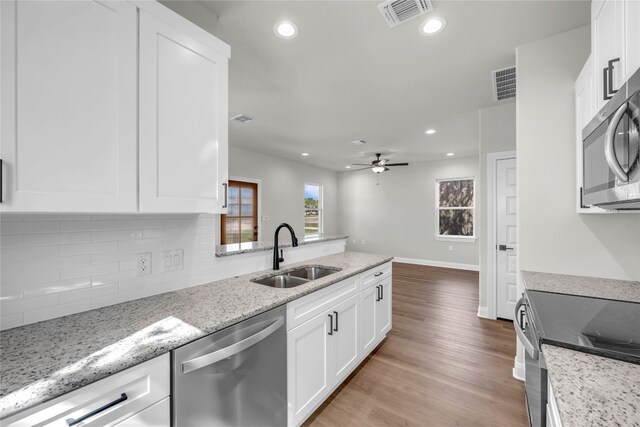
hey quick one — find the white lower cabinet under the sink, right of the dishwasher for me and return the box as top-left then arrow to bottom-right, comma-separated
287,263 -> 391,426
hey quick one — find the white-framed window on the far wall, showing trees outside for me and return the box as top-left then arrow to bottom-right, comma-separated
435,178 -> 475,240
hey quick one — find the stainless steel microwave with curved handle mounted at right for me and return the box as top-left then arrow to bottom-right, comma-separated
582,70 -> 640,210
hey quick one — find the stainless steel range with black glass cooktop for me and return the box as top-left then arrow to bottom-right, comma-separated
514,291 -> 640,427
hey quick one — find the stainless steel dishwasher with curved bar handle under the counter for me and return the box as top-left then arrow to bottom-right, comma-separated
172,306 -> 287,427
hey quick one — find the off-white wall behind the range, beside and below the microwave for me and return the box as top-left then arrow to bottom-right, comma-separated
515,27 -> 640,371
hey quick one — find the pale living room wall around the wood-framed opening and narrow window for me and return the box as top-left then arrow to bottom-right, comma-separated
229,146 -> 338,240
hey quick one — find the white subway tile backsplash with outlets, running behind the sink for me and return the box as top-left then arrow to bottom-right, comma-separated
0,214 -> 344,329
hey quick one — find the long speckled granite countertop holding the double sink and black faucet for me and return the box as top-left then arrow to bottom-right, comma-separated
0,252 -> 392,418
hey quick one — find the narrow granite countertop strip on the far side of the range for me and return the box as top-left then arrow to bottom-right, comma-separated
521,271 -> 640,302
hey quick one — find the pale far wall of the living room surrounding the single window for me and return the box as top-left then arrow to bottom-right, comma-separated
338,157 -> 478,267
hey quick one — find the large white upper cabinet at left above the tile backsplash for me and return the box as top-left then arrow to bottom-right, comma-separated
0,0 -> 229,213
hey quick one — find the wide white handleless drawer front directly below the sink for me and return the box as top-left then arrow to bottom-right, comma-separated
287,276 -> 359,331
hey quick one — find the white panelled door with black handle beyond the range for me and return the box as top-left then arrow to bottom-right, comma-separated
487,152 -> 518,320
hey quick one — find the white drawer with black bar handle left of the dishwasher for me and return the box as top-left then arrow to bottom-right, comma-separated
2,353 -> 170,427
